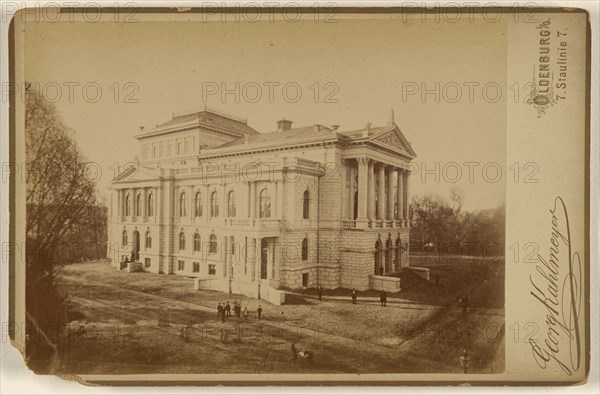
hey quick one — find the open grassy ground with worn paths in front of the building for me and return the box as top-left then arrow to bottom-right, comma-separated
47,262 -> 504,374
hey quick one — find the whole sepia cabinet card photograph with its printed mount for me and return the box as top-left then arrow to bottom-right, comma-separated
3,3 -> 589,384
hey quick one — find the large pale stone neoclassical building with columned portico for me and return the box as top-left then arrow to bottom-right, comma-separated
109,107 -> 415,295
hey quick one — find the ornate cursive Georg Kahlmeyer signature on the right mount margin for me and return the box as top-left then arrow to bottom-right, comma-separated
529,196 -> 583,376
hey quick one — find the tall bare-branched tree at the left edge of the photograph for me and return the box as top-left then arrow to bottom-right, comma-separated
25,86 -> 107,370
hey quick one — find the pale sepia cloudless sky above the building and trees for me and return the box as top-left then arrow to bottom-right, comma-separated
24,12 -> 511,210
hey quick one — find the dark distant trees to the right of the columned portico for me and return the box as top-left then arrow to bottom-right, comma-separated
410,188 -> 505,256
